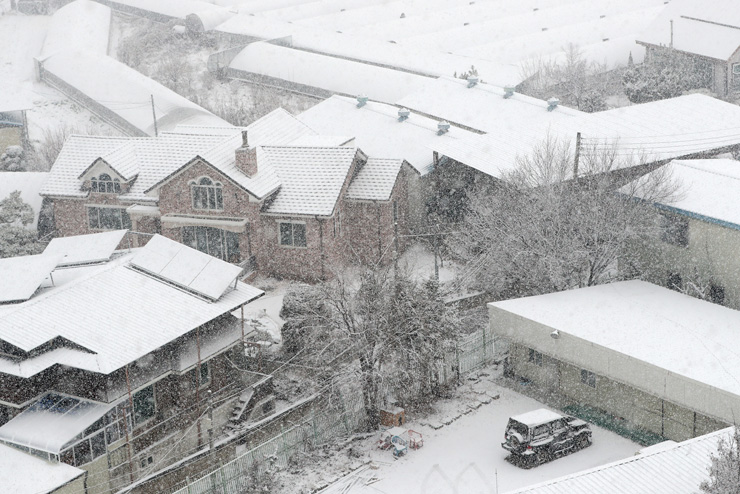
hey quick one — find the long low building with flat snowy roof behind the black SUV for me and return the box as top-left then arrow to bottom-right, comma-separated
489,281 -> 740,441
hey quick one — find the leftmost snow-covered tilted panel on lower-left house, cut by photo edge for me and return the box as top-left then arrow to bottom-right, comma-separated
0,254 -> 61,303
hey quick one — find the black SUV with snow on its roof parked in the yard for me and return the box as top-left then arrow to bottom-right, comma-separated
501,408 -> 591,464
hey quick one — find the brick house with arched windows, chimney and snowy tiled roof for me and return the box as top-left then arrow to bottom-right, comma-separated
42,110 -> 417,280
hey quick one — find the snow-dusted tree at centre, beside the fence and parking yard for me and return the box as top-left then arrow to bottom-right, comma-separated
283,268 -> 457,430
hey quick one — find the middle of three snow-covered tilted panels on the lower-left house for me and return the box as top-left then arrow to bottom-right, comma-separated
44,230 -> 128,268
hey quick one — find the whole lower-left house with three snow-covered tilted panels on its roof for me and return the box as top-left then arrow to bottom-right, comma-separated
0,230 -> 274,494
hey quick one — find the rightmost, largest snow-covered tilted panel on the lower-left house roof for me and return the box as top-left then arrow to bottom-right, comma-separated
131,235 -> 241,300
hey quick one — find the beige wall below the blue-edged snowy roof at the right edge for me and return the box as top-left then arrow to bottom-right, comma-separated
637,218 -> 740,309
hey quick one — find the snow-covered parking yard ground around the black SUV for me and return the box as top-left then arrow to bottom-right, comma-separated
322,376 -> 641,494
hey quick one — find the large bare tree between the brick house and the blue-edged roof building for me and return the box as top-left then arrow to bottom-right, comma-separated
448,138 -> 676,297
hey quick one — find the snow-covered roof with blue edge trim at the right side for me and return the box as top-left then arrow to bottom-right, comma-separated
646,159 -> 740,229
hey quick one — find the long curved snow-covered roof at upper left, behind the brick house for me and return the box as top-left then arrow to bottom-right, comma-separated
43,50 -> 229,135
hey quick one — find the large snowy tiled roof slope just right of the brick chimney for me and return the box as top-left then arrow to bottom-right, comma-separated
258,146 -> 358,216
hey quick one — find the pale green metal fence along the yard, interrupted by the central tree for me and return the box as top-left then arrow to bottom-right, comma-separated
173,327 -> 494,494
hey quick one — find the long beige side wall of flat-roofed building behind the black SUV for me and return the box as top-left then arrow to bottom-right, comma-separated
489,306 -> 740,441
